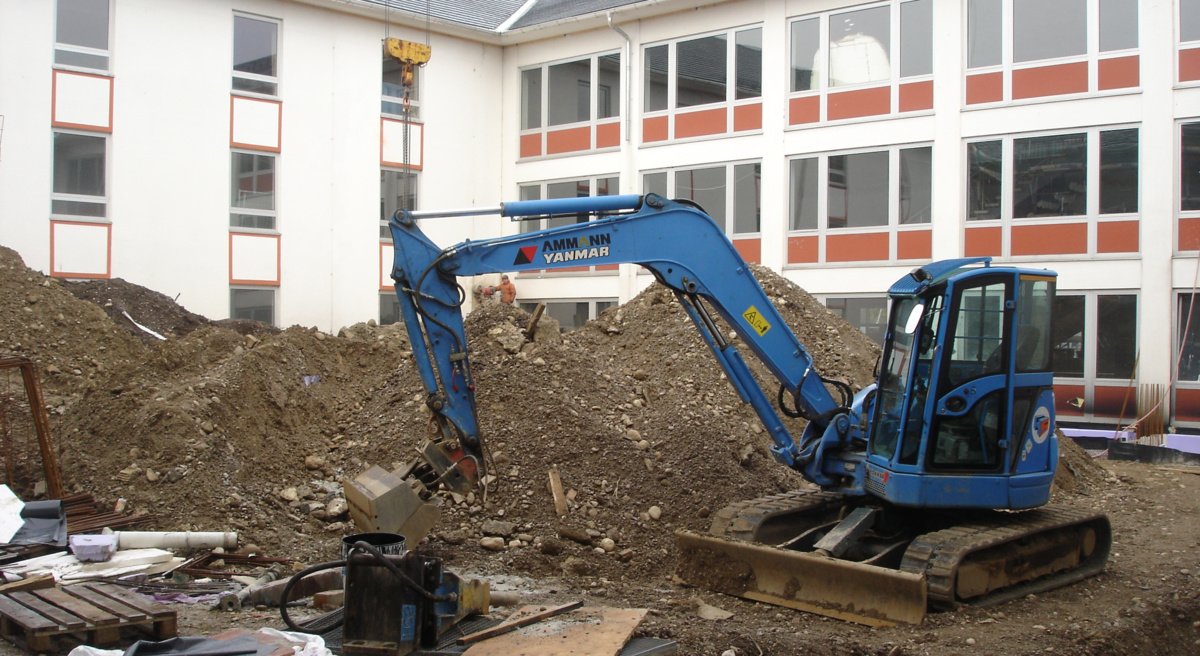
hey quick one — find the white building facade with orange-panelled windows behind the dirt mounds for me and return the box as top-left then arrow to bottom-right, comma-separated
0,0 -> 1200,426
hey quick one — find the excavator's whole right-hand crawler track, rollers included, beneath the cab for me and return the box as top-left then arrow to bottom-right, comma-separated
900,506 -> 1112,608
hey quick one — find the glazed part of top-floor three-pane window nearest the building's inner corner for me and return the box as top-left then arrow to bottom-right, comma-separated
521,53 -> 620,131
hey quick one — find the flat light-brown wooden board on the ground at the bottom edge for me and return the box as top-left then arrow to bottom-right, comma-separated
464,606 -> 646,656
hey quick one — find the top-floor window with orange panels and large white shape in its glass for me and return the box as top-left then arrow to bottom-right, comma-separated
790,0 -> 934,125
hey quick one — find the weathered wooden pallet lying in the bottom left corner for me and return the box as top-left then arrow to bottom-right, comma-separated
0,583 -> 176,651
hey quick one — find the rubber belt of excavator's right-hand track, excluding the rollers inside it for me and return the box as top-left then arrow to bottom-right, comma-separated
900,507 -> 1109,608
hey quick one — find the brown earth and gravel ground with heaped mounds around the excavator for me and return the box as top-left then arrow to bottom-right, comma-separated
0,248 -> 1200,656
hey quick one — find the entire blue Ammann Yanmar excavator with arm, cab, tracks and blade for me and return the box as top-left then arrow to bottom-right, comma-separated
390,194 -> 1112,625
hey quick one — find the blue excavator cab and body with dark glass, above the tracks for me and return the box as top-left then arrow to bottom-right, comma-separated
865,258 -> 1057,508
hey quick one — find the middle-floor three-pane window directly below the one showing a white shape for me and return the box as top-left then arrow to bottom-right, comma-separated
788,146 -> 934,264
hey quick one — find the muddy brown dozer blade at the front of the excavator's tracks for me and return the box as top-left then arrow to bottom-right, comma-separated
676,531 -> 928,626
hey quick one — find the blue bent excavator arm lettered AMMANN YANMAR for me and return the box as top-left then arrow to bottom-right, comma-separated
390,194 -> 865,494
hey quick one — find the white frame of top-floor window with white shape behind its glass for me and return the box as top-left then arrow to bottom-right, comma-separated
785,0 -> 935,124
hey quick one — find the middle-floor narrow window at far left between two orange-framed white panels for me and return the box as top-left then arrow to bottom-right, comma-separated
50,132 -> 108,218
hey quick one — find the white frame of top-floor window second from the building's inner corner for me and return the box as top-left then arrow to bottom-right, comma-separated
638,22 -> 766,133
